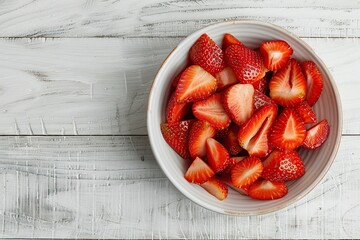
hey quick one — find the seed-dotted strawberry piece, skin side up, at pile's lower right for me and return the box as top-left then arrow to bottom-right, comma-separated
262,150 -> 305,182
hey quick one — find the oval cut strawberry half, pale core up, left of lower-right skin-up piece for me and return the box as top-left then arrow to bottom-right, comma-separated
231,157 -> 264,188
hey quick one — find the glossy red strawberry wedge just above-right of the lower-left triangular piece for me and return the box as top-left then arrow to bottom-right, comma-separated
205,138 -> 230,173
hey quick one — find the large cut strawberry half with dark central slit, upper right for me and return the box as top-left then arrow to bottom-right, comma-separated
269,59 -> 306,107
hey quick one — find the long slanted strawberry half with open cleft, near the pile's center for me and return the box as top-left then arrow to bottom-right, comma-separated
238,105 -> 277,157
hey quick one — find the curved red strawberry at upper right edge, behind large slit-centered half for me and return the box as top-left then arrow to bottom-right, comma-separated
301,61 -> 324,106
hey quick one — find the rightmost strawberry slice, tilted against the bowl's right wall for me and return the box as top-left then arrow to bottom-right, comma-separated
302,119 -> 330,150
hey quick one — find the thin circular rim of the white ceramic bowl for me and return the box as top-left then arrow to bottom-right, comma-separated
147,20 -> 343,216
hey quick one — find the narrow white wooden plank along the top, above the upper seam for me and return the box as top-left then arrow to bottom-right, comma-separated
0,0 -> 360,37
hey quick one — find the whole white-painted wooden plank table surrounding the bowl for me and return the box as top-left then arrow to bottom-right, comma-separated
0,0 -> 360,239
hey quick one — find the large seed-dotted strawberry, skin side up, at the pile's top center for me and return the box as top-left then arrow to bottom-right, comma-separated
225,45 -> 265,83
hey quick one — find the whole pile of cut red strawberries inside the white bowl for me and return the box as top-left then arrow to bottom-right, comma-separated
161,34 -> 330,200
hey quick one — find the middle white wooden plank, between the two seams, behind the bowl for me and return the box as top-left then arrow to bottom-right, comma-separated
0,38 -> 360,135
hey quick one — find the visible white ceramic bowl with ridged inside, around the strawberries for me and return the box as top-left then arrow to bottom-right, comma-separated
147,21 -> 342,215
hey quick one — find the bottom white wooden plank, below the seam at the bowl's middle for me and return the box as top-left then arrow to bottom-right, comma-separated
0,136 -> 360,239
